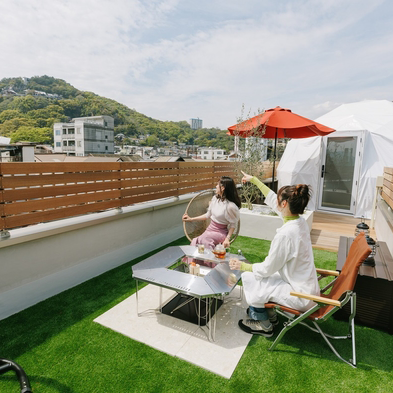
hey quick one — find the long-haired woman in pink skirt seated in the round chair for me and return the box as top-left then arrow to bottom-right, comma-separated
182,176 -> 241,249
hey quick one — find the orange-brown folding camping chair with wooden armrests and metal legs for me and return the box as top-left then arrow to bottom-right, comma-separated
265,233 -> 371,367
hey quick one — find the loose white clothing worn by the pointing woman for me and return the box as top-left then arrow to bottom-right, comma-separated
242,184 -> 320,310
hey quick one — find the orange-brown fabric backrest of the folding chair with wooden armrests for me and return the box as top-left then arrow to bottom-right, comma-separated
312,233 -> 371,318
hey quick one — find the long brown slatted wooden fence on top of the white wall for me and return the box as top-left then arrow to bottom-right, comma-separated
0,161 -> 235,230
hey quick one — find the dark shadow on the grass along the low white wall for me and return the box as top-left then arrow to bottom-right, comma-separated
0,237 -> 188,359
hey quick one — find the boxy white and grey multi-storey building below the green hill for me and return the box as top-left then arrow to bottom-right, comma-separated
53,116 -> 114,156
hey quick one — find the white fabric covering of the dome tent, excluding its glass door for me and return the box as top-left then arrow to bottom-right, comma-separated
277,100 -> 393,218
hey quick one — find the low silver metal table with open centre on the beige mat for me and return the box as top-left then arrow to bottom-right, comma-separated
132,246 -> 245,341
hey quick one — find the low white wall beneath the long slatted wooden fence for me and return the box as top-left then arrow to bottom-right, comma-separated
0,194 -> 194,320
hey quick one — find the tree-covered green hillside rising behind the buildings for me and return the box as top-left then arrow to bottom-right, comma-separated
0,75 -> 233,151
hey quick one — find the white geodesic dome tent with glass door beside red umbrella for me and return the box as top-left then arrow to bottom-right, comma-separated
277,100 -> 393,218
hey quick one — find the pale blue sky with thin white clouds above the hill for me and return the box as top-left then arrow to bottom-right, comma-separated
0,0 -> 393,129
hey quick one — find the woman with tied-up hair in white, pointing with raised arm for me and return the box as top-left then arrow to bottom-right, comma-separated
229,173 -> 320,337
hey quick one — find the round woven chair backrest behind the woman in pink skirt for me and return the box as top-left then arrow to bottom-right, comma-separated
183,190 -> 240,243
